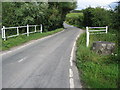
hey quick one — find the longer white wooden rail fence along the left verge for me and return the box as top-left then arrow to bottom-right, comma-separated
1,24 -> 42,41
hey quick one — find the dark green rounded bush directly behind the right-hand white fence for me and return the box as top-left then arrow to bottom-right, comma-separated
83,7 -> 110,26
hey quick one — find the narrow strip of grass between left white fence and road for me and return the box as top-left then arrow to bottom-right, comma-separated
2,28 -> 63,51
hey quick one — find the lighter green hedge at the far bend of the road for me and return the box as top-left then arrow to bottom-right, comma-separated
66,13 -> 83,27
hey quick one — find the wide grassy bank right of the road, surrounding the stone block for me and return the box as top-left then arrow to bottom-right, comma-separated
76,33 -> 119,88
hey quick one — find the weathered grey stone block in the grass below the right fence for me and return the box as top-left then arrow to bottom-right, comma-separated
92,41 -> 115,55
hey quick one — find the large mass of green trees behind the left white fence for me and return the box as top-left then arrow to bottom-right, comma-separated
2,2 -> 76,31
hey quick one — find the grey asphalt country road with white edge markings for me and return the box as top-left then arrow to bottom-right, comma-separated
2,24 -> 83,88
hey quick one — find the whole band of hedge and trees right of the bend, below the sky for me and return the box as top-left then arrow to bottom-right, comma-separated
66,5 -> 120,31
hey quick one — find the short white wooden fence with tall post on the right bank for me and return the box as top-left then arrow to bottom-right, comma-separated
86,26 -> 108,47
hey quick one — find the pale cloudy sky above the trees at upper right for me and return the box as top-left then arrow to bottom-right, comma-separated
76,0 -> 119,10
